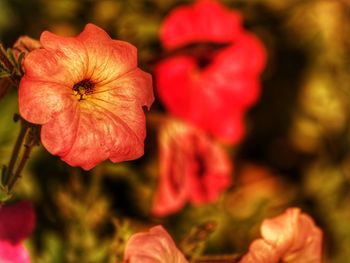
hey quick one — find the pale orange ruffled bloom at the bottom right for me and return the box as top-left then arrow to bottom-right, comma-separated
240,208 -> 322,263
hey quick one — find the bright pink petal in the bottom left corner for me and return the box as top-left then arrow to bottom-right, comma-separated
0,240 -> 30,263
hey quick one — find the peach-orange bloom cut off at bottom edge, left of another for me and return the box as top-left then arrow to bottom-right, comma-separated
124,226 -> 188,263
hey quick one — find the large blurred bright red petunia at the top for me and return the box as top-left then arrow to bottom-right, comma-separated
155,0 -> 266,143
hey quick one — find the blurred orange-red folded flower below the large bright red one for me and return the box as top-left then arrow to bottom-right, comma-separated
152,119 -> 232,216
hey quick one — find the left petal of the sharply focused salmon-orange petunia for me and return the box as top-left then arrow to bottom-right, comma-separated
18,75 -> 75,124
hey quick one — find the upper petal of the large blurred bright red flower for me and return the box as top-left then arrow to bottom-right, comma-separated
160,0 -> 241,49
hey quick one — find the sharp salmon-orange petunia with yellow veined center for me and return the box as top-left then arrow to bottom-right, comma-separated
19,24 -> 153,170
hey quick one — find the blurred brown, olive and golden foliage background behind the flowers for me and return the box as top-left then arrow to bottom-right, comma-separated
0,0 -> 350,263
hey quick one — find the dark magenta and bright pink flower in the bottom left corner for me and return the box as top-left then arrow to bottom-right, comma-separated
0,201 -> 35,263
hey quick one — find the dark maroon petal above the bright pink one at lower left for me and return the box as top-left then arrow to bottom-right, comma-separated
0,201 -> 35,244
